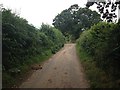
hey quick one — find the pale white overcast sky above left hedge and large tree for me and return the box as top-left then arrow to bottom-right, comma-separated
0,0 -> 98,28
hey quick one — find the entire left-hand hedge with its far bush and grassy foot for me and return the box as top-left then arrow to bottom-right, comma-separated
2,9 -> 65,88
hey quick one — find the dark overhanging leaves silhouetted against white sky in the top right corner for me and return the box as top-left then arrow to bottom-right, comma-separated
86,0 -> 120,22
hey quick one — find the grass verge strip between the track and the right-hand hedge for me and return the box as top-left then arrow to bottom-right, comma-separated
76,44 -> 114,88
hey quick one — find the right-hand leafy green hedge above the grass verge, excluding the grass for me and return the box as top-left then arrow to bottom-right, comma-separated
77,22 -> 120,87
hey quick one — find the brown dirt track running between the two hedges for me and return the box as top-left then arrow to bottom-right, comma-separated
20,44 -> 89,88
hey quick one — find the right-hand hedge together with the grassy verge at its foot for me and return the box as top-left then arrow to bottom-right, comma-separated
76,21 -> 120,88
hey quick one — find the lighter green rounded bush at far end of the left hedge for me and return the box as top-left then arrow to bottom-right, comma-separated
40,24 -> 65,54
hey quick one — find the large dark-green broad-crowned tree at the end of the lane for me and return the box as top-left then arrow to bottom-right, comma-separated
53,4 -> 101,40
